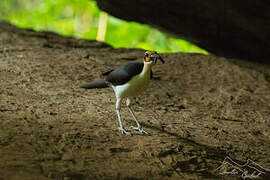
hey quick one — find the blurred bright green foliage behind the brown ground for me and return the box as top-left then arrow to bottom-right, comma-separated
0,0 -> 207,53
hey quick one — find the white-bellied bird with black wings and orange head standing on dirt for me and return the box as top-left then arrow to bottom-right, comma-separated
80,50 -> 165,135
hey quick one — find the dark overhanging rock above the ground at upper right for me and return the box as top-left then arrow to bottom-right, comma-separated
97,0 -> 270,63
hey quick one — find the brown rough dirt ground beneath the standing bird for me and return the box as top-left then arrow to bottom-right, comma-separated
0,22 -> 270,180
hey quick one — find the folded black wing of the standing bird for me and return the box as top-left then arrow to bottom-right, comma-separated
103,62 -> 144,86
